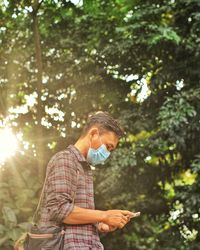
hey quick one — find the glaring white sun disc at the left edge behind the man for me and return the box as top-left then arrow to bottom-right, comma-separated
0,128 -> 18,165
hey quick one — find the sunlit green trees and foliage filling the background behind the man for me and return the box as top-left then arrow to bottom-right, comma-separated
0,0 -> 200,250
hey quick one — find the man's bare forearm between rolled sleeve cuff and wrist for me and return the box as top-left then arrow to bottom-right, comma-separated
63,206 -> 105,224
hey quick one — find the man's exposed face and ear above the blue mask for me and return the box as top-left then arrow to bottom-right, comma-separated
91,129 -> 119,152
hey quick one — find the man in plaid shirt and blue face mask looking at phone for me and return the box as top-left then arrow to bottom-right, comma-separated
40,112 -> 138,250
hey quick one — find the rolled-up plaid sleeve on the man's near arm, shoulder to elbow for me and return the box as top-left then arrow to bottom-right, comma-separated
46,153 -> 77,223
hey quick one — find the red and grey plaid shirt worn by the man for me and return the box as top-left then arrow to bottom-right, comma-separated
39,145 -> 104,250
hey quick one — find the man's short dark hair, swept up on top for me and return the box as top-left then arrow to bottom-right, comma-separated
82,111 -> 125,138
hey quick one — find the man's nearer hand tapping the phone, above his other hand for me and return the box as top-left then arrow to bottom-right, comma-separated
102,210 -> 134,228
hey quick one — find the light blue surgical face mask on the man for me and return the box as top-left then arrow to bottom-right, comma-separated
87,134 -> 110,166
